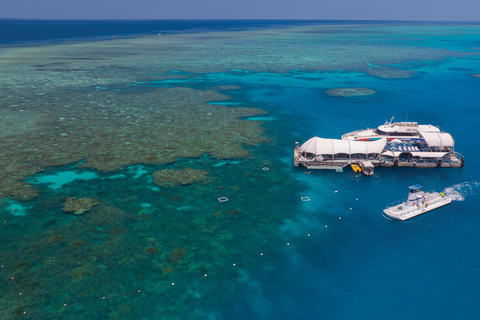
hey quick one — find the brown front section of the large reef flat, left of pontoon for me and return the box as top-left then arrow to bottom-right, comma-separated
0,88 -> 265,200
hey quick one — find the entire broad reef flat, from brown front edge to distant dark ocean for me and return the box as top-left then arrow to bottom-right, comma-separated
0,25 -> 464,200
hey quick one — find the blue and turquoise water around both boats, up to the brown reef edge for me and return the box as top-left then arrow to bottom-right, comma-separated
0,21 -> 480,319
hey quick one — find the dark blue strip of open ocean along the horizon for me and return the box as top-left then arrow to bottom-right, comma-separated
0,19 -> 390,44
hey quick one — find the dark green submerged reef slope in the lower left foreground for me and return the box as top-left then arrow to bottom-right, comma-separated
0,145 -> 299,319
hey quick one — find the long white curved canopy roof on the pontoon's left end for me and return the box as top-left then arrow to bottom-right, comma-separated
300,137 -> 387,154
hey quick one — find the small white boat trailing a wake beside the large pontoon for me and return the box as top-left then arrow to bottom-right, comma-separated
383,184 -> 452,220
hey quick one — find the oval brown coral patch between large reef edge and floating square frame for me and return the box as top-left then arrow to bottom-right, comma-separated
153,168 -> 209,187
